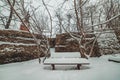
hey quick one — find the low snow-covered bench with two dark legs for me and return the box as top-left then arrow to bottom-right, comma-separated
44,52 -> 89,70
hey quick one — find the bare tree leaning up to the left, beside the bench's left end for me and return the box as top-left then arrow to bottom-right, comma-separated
7,0 -> 49,62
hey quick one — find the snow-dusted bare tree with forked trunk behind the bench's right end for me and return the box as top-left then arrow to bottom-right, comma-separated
60,0 -> 120,58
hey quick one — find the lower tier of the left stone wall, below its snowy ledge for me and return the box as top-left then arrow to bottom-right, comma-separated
0,44 -> 44,64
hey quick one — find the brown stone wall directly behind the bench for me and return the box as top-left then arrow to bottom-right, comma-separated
55,33 -> 100,57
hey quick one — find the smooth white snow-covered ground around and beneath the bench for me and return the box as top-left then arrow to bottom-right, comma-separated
0,48 -> 120,80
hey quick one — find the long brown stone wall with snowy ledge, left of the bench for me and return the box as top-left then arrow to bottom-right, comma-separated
0,30 -> 44,64
